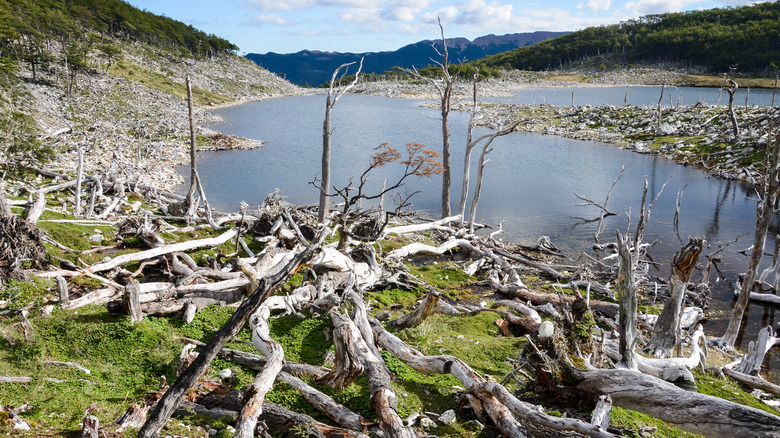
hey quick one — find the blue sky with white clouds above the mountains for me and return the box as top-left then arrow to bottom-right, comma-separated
126,0 -> 755,54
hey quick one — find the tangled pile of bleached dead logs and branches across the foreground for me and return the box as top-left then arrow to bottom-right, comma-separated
4,169 -> 780,437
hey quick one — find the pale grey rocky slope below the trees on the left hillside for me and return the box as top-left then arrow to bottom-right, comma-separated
9,39 -> 301,193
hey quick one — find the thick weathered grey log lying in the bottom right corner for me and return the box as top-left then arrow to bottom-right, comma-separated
577,369 -> 780,438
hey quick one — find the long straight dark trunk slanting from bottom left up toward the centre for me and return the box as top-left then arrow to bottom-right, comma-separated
138,230 -> 326,438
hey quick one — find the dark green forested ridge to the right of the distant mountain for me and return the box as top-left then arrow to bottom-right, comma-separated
475,2 -> 780,74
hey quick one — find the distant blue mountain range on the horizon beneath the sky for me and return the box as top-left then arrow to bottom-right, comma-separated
246,32 -> 567,86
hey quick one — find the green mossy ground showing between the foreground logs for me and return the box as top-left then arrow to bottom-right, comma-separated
0,185 -> 771,437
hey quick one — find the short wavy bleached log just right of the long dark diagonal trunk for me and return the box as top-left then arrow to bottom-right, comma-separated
235,306 -> 284,438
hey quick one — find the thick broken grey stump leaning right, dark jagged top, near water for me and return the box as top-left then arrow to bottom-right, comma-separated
648,238 -> 702,357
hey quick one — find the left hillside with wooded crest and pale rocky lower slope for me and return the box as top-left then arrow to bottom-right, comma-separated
0,0 -> 299,187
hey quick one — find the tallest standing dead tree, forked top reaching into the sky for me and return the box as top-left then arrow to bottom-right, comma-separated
405,17 -> 458,218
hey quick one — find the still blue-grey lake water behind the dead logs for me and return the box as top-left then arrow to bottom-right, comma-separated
182,87 -> 780,369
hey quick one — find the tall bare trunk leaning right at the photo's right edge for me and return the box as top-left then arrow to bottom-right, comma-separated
720,128 -> 780,349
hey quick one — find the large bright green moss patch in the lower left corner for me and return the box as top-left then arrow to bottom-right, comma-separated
0,306 -> 181,435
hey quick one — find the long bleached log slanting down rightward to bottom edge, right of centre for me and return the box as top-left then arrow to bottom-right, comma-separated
372,322 -> 614,438
